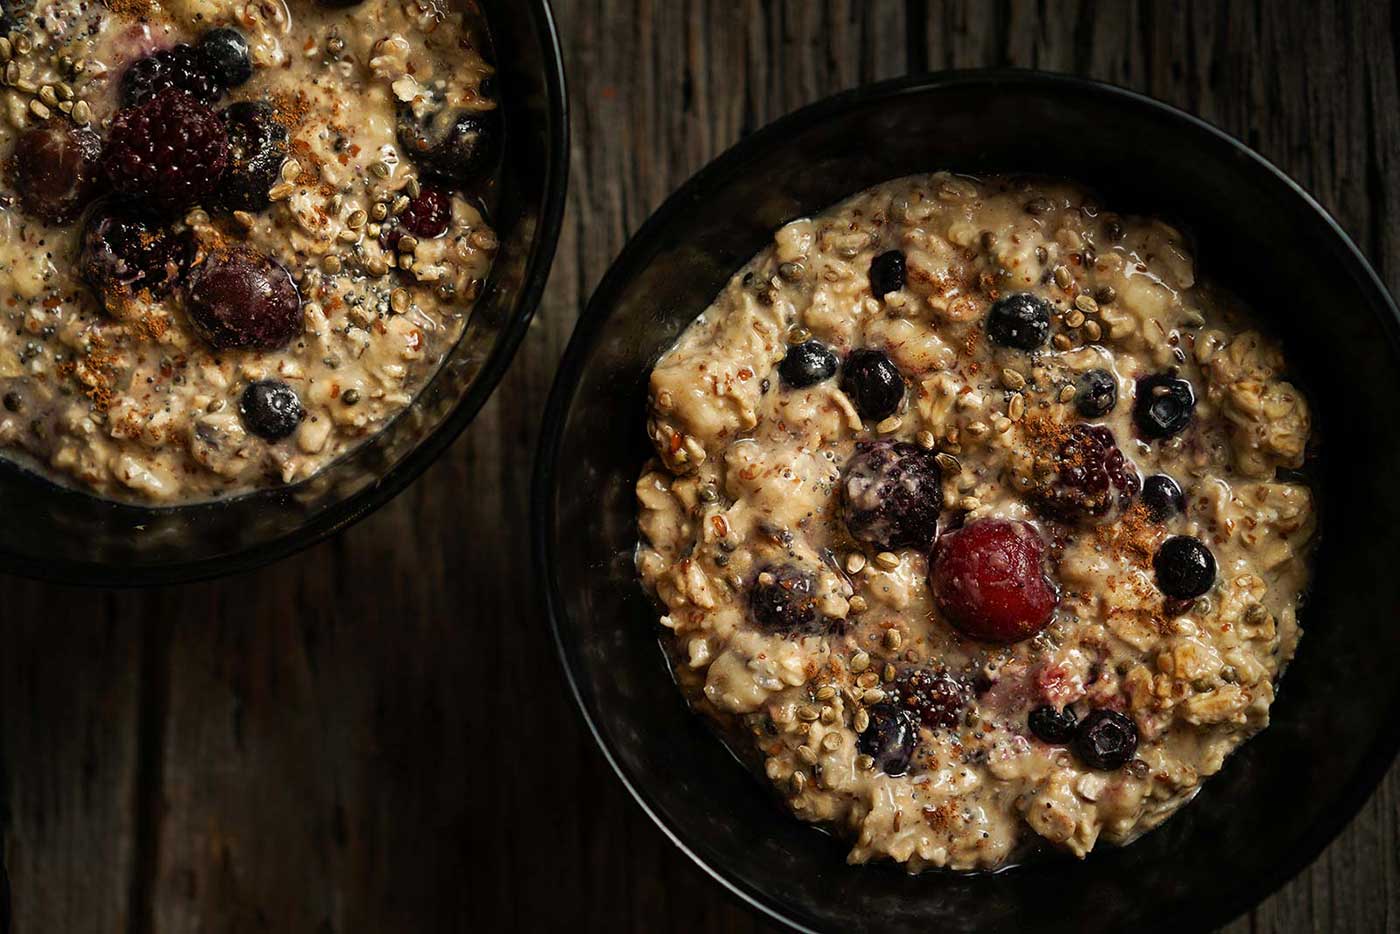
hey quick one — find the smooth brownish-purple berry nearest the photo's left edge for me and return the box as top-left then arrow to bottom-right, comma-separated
10,120 -> 102,224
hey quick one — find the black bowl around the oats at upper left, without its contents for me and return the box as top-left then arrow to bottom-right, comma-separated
0,0 -> 568,585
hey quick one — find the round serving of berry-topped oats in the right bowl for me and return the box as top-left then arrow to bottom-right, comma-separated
637,174 -> 1316,871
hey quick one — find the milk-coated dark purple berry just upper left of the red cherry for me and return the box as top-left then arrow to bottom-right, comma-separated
841,441 -> 944,550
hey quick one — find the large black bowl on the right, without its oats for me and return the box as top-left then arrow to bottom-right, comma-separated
533,71 -> 1400,931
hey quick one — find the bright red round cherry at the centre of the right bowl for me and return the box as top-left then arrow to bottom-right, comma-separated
928,518 -> 1060,643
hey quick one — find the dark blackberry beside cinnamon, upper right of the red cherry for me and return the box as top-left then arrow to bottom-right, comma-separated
1033,424 -> 1138,522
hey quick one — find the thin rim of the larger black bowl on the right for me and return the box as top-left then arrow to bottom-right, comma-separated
531,67 -> 1400,934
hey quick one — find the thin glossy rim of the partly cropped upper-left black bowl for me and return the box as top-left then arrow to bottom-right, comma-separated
4,0 -> 571,588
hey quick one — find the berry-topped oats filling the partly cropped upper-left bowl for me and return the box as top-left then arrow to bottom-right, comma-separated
0,0 -> 501,504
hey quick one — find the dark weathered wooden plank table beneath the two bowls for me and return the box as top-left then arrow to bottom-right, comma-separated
0,0 -> 1400,934
